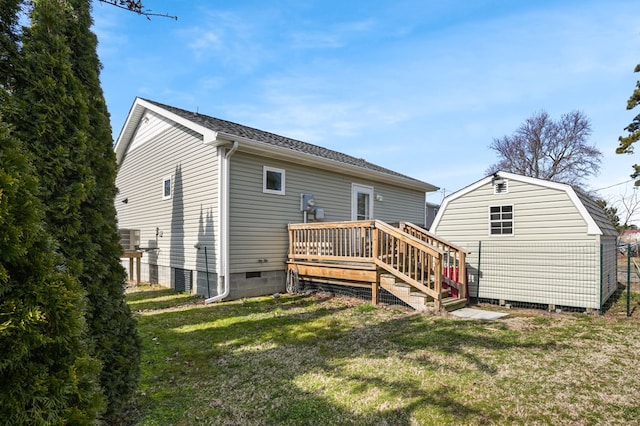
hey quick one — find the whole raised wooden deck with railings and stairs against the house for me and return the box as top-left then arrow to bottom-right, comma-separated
287,220 -> 467,310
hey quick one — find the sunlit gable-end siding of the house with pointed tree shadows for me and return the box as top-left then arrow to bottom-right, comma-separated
116,114 -> 219,292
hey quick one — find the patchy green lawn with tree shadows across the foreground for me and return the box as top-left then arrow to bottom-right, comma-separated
127,286 -> 640,426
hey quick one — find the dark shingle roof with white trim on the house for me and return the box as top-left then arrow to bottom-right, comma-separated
115,98 -> 439,192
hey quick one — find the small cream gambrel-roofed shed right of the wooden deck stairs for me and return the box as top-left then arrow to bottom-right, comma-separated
431,171 -> 618,309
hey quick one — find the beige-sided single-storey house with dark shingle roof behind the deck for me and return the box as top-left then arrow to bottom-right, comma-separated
115,98 -> 438,301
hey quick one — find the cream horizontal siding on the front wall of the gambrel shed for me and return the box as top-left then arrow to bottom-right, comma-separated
433,180 -> 610,308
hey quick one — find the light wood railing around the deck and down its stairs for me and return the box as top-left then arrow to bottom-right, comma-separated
288,220 -> 466,305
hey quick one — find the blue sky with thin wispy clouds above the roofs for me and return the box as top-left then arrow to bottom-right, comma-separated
94,0 -> 640,223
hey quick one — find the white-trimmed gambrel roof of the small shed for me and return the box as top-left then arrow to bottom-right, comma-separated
432,171 -> 618,236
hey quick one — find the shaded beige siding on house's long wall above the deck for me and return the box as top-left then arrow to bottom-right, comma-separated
230,151 -> 425,273
